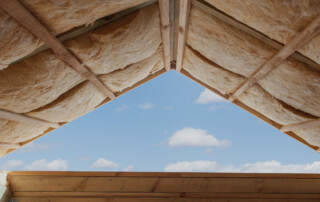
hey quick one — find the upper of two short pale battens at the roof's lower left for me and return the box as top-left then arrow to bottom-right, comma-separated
0,109 -> 60,128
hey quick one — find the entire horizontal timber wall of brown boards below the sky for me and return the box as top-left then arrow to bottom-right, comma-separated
8,171 -> 320,202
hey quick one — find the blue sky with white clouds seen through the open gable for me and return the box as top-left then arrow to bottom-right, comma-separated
0,71 -> 320,173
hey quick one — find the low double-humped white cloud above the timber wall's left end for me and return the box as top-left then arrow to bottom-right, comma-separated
23,159 -> 68,171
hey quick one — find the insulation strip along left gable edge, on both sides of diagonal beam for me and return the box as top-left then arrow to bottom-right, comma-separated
27,46 -> 164,122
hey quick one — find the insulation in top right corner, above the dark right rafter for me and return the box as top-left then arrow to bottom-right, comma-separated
206,0 -> 320,64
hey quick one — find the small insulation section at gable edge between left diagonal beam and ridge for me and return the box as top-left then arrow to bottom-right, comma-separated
99,46 -> 164,92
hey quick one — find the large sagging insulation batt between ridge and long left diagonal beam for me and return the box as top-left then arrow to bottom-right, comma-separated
65,4 -> 161,74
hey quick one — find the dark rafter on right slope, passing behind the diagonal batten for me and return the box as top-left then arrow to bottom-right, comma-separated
192,0 -> 320,70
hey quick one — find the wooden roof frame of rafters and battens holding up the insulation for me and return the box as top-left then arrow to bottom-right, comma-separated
0,0 -> 320,153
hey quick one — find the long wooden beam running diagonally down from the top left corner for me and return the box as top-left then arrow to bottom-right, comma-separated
0,0 -> 115,99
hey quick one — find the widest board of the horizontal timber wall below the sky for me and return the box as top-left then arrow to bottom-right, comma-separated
8,176 -> 320,194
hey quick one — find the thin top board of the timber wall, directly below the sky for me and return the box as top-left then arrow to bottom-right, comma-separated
8,171 -> 320,179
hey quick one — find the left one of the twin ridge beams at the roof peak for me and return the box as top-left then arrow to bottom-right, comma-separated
158,0 -> 172,71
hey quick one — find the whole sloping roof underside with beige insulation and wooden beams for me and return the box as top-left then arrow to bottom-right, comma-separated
0,0 -> 320,156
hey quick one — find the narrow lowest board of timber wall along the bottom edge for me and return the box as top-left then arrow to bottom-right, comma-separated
13,197 -> 319,202
